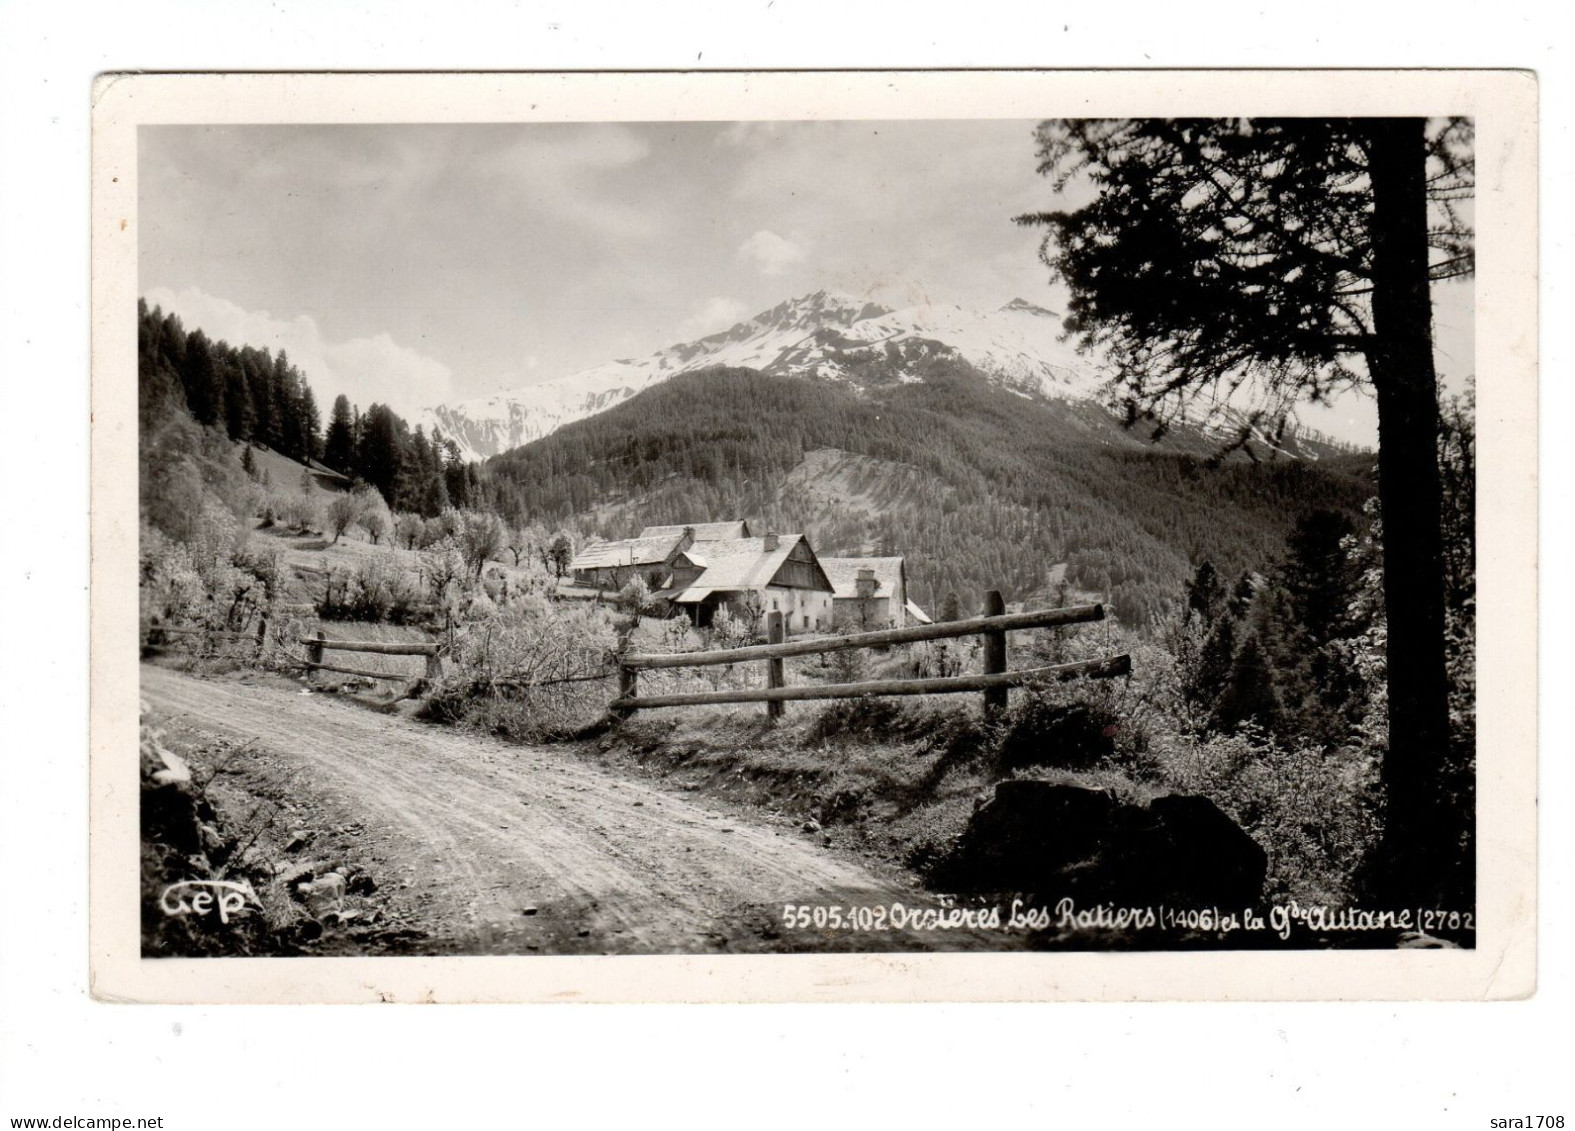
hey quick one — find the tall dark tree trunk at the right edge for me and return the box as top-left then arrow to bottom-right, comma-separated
1367,118 -> 1473,907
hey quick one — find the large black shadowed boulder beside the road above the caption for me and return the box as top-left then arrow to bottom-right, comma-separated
929,780 -> 1268,907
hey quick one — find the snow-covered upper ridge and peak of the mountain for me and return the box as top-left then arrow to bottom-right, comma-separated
417,290 -> 1099,458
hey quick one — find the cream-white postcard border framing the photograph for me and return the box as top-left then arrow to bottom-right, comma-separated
90,71 -> 1537,1003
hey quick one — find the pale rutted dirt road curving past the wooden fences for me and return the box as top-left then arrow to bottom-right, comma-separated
142,665 -> 982,953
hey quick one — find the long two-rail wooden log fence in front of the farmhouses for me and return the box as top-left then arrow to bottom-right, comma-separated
610,589 -> 1132,718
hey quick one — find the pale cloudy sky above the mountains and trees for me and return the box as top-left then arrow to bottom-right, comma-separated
139,121 -> 1471,443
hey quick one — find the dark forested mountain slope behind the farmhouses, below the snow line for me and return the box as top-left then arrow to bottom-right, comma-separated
488,359 -> 1372,624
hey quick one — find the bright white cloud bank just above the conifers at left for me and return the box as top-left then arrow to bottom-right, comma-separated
145,287 -> 454,419
